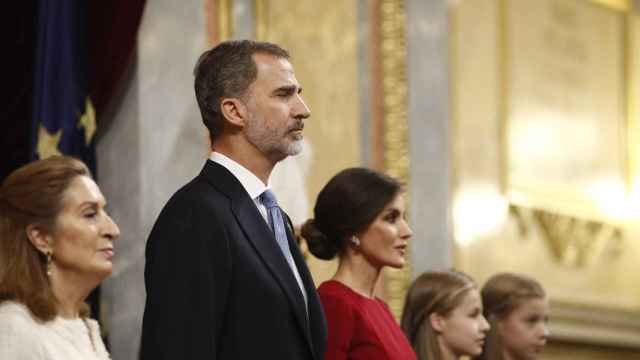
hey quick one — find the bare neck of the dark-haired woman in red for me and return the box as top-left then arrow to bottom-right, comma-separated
333,250 -> 381,298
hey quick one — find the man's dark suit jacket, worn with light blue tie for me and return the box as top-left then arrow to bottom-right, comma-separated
140,160 -> 327,360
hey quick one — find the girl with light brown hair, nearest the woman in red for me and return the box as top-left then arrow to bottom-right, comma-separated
402,271 -> 489,360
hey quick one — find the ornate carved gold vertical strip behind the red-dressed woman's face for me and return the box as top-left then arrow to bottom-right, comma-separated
379,0 -> 411,319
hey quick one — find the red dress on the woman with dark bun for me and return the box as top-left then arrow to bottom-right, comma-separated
318,280 -> 416,360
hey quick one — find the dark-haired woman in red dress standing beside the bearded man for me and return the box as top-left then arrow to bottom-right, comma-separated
302,168 -> 416,360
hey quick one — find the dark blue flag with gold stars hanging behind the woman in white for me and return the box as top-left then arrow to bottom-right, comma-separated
30,0 -> 96,174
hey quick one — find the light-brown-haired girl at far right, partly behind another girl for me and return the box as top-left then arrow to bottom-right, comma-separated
479,273 -> 549,360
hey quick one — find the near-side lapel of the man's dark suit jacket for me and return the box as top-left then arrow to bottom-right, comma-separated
201,160 -> 315,356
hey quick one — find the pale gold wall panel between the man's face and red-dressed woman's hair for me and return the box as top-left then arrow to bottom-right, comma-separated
256,0 -> 361,284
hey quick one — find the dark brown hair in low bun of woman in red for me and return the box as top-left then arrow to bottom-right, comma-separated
301,168 -> 402,260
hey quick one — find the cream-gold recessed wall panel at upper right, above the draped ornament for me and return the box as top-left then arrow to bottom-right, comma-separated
502,0 -> 628,221
